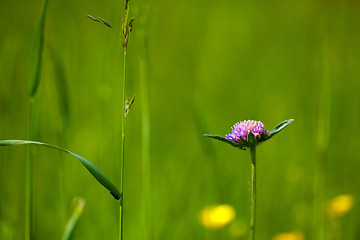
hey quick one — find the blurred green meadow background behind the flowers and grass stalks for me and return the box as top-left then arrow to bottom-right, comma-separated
0,0 -> 360,240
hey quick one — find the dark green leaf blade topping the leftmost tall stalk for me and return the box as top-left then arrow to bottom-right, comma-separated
29,0 -> 48,98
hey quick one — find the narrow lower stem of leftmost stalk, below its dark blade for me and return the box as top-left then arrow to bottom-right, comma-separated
25,98 -> 34,240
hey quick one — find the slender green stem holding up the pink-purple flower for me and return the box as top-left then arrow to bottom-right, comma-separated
249,146 -> 256,240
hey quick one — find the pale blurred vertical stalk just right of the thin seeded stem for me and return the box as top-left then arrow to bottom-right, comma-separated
137,1 -> 152,240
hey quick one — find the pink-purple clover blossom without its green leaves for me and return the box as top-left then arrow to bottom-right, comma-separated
225,120 -> 269,142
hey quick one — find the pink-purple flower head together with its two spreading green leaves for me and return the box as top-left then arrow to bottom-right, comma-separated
205,119 -> 293,149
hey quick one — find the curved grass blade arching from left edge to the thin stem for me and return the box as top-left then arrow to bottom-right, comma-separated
0,140 -> 120,200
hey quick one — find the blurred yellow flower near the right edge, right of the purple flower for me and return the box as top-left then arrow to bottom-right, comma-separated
327,194 -> 354,218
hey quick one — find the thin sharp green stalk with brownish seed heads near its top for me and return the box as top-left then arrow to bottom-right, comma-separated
119,0 -> 130,240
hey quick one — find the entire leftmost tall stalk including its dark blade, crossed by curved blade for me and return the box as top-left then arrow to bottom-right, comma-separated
25,0 -> 48,237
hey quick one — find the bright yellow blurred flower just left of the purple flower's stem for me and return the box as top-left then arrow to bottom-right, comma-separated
200,204 -> 236,228
